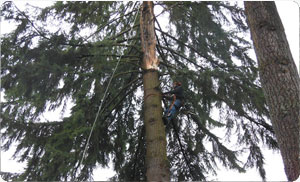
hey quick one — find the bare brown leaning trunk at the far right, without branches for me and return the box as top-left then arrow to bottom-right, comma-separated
244,1 -> 300,181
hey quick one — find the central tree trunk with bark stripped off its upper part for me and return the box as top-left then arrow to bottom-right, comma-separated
140,1 -> 170,181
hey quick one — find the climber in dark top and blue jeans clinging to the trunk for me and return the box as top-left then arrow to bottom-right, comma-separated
163,81 -> 184,124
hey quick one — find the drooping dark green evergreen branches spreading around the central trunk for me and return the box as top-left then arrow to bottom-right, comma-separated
1,1 -> 278,181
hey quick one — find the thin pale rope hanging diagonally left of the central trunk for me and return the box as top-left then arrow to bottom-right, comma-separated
79,2 -> 139,178
